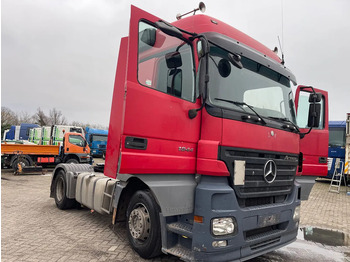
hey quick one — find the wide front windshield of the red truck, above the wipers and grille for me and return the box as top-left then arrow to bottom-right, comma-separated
208,45 -> 295,123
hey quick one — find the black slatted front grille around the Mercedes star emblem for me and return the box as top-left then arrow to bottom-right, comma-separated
219,147 -> 298,207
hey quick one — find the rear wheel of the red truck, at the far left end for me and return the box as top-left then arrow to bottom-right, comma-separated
53,170 -> 77,210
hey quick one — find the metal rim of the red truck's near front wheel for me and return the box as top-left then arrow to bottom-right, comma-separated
128,204 -> 151,241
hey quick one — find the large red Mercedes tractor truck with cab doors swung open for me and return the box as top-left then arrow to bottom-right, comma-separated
51,4 -> 328,261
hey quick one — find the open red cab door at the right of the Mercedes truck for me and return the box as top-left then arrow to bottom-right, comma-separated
295,86 -> 329,176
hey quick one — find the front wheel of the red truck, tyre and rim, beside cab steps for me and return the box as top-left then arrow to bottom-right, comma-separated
126,190 -> 161,258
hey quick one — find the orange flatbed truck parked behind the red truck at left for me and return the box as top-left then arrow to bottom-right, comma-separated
1,133 -> 92,171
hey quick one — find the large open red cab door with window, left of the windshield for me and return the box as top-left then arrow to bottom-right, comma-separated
117,6 -> 201,174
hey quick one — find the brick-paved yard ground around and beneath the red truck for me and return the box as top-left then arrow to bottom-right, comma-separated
1,170 -> 350,262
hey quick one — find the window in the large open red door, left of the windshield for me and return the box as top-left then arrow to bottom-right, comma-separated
138,21 -> 195,102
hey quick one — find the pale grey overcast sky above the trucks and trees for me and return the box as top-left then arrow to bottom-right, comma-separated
1,0 -> 350,126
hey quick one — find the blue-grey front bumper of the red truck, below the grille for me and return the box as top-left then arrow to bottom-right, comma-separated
192,176 -> 300,261
